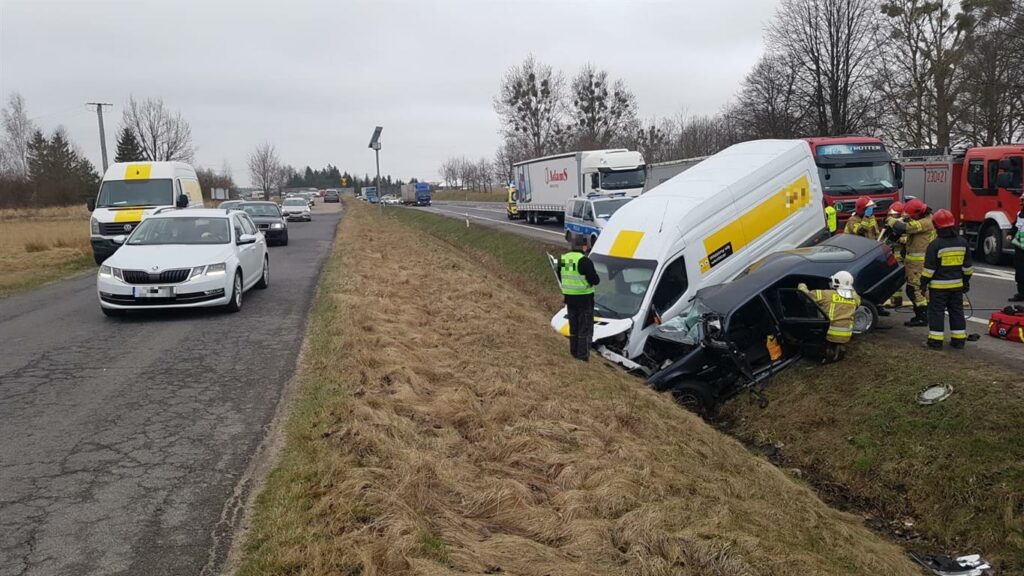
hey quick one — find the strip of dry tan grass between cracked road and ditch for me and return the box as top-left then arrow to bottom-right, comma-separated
239,203 -> 918,576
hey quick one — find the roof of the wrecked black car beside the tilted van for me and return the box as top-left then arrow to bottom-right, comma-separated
696,234 -> 881,313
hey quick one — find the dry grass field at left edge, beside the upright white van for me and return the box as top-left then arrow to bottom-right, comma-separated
0,206 -> 94,297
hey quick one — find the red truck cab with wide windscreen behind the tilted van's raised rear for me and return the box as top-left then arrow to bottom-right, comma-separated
805,136 -> 902,231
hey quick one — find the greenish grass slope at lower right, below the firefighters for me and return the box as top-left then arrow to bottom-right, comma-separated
723,334 -> 1024,574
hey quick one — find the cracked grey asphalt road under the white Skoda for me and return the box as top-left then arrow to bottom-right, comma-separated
0,204 -> 340,576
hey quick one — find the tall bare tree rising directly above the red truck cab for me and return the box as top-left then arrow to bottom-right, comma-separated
767,0 -> 878,135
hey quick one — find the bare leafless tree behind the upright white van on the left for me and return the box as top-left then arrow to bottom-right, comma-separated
121,96 -> 194,162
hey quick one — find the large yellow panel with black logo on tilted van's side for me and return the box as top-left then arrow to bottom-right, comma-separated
700,176 -> 811,273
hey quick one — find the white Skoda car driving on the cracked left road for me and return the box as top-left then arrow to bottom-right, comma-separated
96,208 -> 270,316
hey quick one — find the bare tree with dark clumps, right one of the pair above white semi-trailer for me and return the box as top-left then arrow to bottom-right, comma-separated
570,64 -> 638,150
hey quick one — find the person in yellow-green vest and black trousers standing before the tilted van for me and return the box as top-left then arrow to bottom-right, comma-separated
558,236 -> 601,362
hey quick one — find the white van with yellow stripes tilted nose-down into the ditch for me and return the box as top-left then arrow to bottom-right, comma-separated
551,140 -> 827,369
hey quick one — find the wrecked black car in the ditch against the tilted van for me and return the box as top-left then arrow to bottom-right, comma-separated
646,235 -> 904,415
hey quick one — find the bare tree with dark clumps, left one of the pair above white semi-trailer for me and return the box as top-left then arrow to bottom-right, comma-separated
495,54 -> 565,157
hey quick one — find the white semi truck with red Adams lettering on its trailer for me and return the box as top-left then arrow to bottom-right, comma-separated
513,149 -> 646,223
